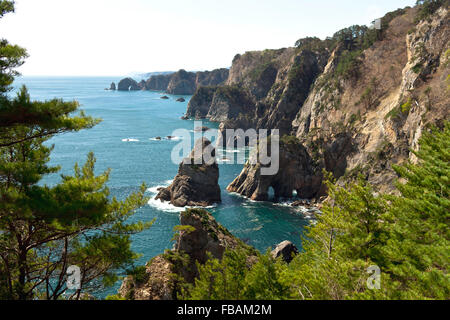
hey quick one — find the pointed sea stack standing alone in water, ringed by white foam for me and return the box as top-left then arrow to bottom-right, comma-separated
156,138 -> 221,207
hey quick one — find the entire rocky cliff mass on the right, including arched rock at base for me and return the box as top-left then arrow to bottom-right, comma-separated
187,2 -> 450,199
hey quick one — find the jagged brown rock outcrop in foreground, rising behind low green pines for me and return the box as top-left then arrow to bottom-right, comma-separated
119,209 -> 256,300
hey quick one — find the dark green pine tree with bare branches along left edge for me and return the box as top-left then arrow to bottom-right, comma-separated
0,0 -> 151,300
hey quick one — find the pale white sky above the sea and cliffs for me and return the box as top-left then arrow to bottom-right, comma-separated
0,0 -> 415,76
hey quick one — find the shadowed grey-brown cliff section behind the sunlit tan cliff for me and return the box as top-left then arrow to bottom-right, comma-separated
187,48 -> 329,134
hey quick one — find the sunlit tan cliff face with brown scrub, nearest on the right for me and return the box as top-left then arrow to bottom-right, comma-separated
293,8 -> 450,192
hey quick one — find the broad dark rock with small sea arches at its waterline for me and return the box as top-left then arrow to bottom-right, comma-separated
227,138 -> 324,201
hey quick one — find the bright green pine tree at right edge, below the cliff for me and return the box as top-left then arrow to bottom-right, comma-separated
383,122 -> 450,299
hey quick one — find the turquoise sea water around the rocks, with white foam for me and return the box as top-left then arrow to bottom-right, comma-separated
14,77 -> 309,297
